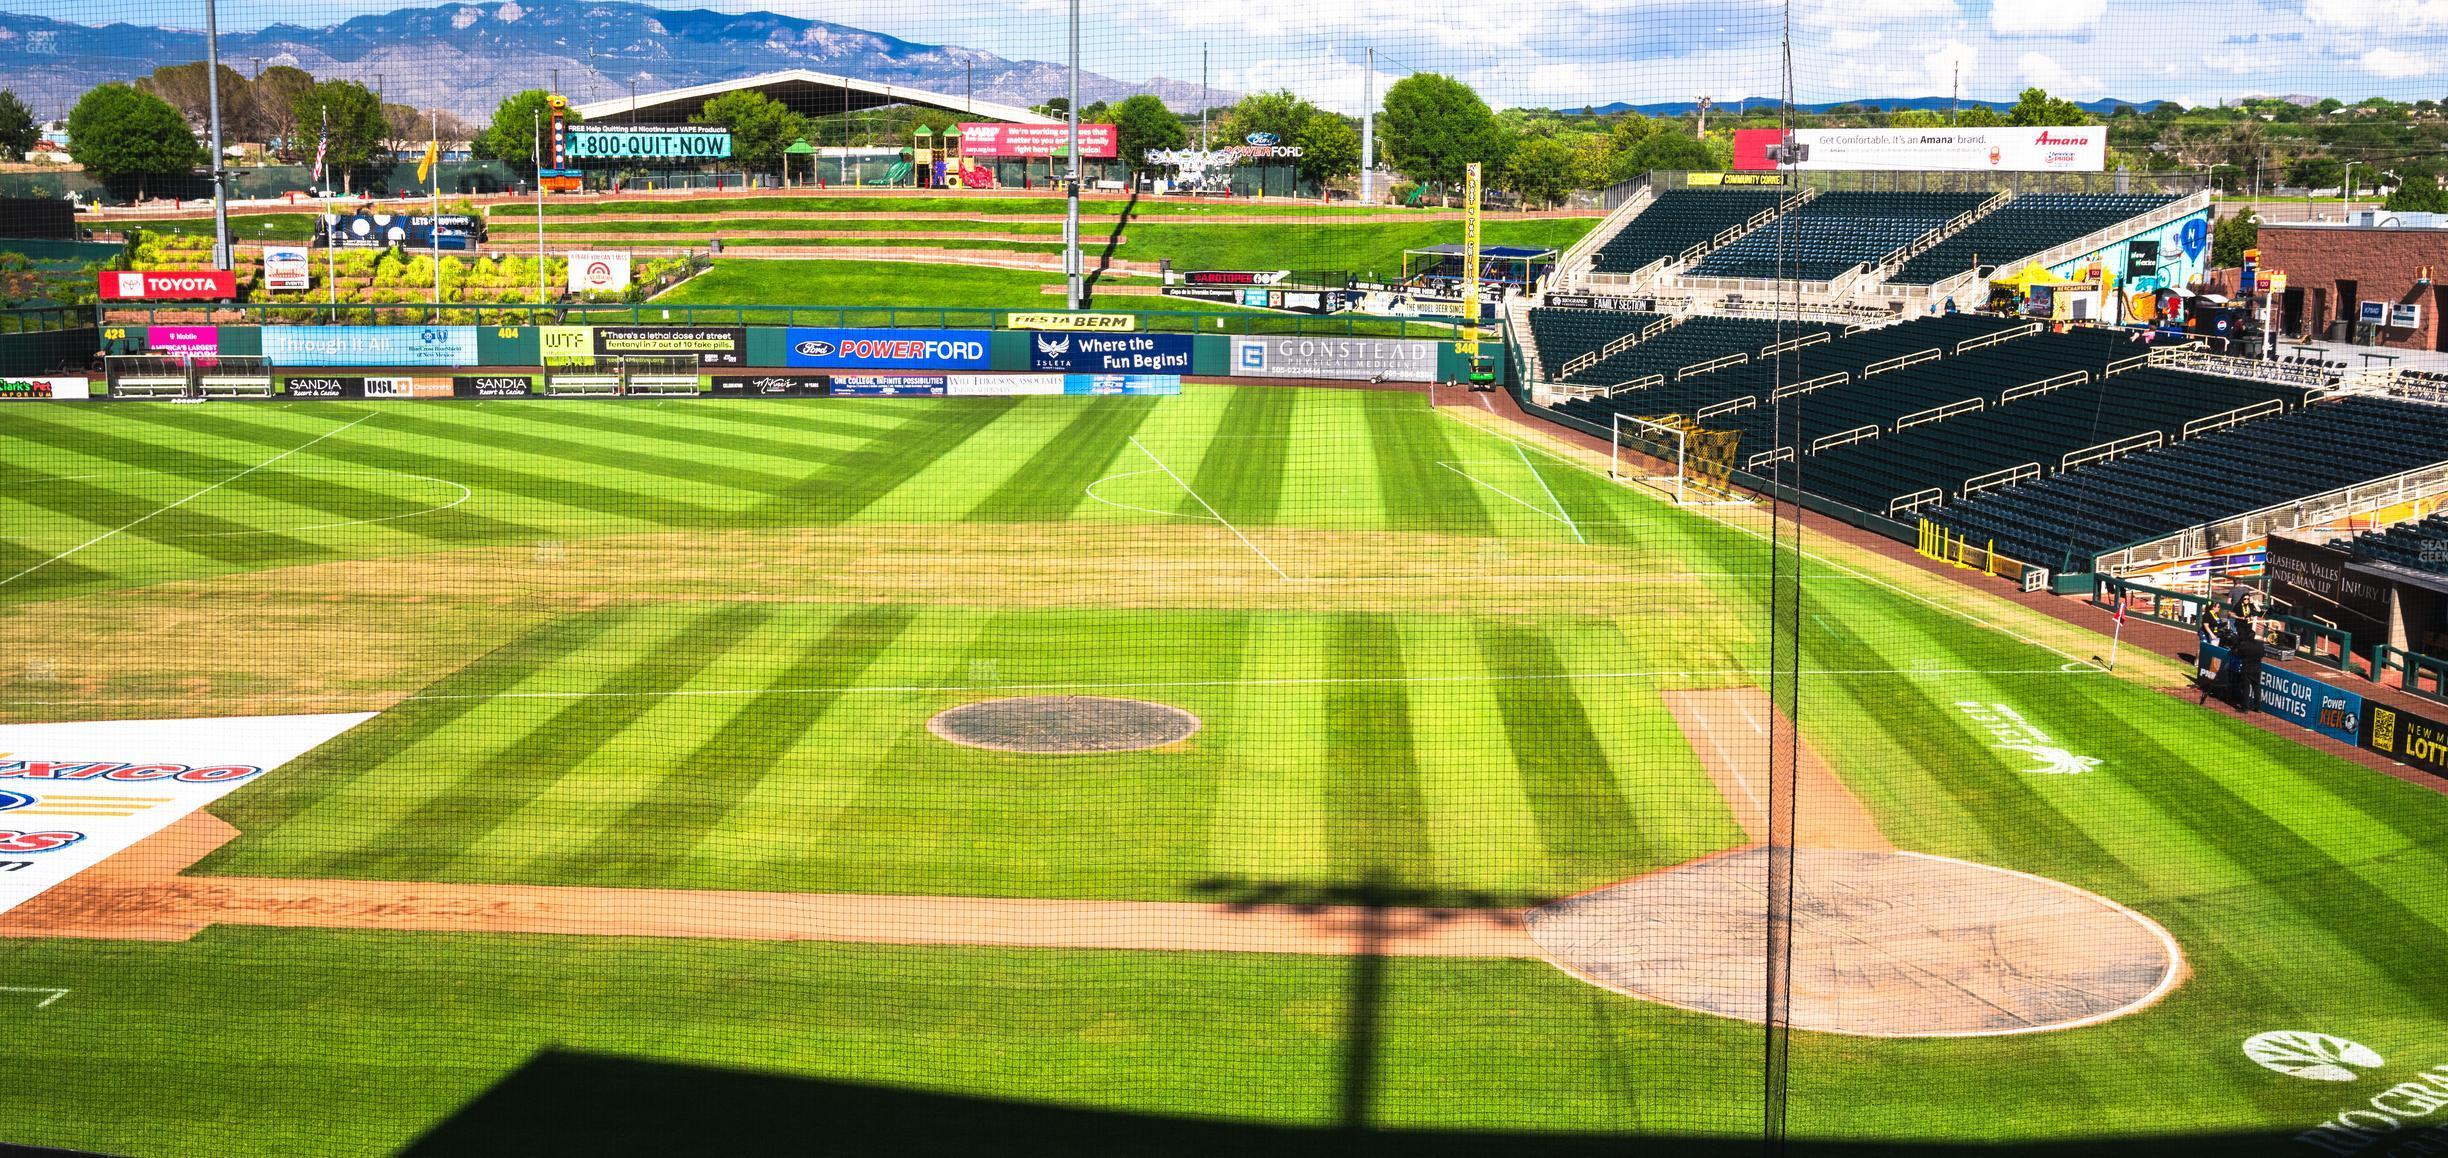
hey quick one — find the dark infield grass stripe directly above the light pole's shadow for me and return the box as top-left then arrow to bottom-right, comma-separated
1319,614 -> 1442,886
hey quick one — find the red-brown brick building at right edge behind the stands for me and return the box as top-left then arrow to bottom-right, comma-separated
2230,211 -> 2448,350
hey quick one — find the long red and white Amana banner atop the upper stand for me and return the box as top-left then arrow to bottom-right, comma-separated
1733,125 -> 2108,174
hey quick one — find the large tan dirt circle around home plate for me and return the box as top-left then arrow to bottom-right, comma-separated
1525,850 -> 2184,1038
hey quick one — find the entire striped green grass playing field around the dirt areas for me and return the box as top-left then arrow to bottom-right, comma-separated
0,387 -> 2448,1156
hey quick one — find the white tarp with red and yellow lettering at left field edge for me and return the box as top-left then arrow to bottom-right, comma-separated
0,712 -> 375,913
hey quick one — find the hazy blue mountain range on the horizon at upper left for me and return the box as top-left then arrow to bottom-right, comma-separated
0,0 -> 1239,118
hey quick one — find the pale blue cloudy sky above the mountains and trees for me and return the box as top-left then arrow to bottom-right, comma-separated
5,0 -> 2448,110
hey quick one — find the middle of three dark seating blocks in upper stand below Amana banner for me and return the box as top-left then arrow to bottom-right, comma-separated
1692,191 -> 1990,282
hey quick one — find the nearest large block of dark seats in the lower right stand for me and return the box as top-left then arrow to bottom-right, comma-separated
1919,396 -> 2448,570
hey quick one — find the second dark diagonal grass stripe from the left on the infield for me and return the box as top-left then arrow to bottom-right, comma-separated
353,605 -> 774,881
